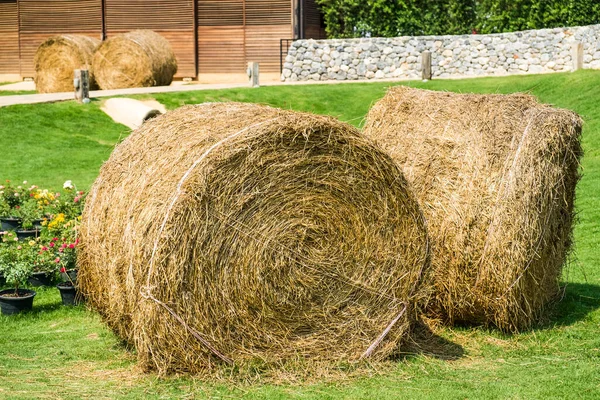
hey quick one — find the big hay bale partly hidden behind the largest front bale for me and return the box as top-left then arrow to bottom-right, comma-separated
365,87 -> 582,331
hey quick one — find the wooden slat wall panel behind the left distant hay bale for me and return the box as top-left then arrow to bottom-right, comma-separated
19,0 -> 102,77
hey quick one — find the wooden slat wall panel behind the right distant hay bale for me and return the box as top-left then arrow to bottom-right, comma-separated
104,0 -> 196,78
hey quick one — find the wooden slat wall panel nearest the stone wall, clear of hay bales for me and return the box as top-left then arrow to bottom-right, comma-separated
197,0 -> 292,73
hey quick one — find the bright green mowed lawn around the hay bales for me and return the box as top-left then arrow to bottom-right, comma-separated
0,71 -> 600,399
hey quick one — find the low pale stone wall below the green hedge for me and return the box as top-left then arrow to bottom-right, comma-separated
281,25 -> 600,81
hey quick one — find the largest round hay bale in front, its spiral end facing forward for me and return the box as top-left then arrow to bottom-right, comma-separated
79,103 -> 428,372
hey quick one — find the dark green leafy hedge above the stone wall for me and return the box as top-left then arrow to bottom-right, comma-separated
317,0 -> 600,38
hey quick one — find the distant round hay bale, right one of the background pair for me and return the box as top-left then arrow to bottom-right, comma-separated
94,30 -> 177,90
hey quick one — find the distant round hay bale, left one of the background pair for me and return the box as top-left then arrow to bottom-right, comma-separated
34,35 -> 100,93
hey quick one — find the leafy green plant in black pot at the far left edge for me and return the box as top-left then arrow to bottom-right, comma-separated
0,232 -> 36,315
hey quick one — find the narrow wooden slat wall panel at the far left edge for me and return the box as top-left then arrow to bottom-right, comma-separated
0,0 -> 20,74
